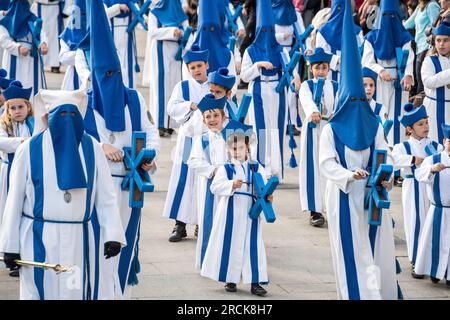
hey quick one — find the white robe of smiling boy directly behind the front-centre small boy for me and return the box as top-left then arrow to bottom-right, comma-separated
188,130 -> 228,271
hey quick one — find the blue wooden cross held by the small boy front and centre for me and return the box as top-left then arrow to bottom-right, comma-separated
249,172 -> 280,223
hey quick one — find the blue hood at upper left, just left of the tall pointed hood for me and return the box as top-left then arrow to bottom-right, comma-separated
60,0 -> 87,51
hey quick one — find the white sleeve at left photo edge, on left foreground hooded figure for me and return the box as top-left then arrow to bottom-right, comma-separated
0,141 -> 30,253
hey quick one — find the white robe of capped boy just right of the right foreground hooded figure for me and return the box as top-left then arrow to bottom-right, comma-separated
392,136 -> 442,264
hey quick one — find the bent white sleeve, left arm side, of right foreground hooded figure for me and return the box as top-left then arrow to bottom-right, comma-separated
319,124 -> 355,193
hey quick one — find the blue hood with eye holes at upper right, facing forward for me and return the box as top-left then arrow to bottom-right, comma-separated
366,0 -> 413,60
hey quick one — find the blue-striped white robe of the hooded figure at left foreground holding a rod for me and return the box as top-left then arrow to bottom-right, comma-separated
0,130 -> 126,300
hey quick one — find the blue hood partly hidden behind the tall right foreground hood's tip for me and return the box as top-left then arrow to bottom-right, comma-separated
319,0 -> 361,51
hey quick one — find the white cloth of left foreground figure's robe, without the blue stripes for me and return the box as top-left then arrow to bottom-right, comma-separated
0,130 -> 126,300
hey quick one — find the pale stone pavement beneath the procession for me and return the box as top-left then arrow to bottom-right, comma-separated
0,27 -> 450,300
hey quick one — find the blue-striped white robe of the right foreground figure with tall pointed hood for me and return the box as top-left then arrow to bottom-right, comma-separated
319,125 -> 397,300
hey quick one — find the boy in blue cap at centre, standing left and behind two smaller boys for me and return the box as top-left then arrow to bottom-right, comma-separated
163,45 -> 209,242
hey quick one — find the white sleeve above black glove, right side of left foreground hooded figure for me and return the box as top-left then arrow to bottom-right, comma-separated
92,141 -> 127,246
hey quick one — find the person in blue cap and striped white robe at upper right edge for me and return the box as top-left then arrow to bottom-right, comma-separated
422,22 -> 450,143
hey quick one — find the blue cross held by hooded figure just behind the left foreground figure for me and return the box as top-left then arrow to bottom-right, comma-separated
121,131 -> 156,208
